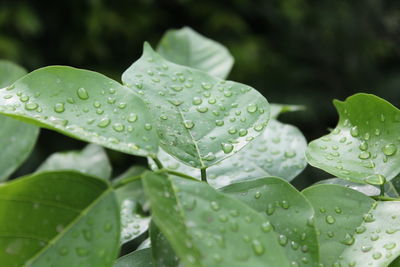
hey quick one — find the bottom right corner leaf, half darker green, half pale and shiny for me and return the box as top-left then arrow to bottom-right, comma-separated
303,184 -> 400,267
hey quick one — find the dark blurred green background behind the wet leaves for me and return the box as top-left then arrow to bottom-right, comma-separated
0,0 -> 400,187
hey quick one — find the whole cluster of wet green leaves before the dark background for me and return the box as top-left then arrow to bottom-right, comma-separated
0,28 -> 400,267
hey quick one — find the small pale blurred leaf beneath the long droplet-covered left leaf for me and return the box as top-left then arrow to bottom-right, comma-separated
37,144 -> 112,179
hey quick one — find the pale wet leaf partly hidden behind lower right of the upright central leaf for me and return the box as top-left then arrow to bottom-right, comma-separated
149,120 -> 307,188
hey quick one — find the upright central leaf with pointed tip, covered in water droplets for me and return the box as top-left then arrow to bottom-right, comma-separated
122,44 -> 269,169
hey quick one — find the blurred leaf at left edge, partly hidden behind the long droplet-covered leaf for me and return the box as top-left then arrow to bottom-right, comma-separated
0,60 -> 39,181
